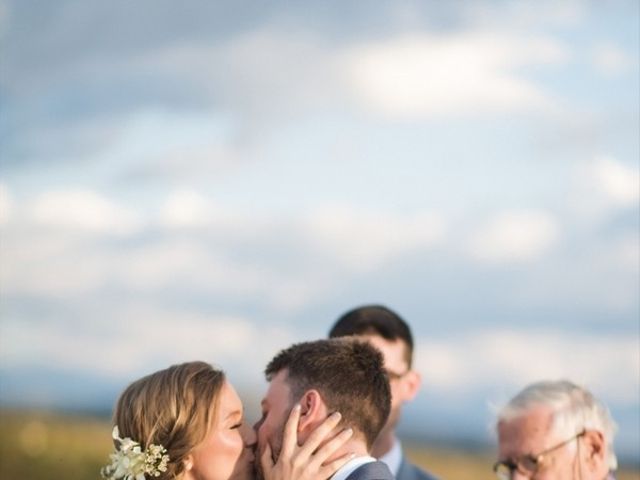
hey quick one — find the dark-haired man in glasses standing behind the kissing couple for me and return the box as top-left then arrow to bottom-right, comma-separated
329,305 -> 436,480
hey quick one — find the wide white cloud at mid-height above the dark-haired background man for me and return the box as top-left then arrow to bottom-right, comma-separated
307,206 -> 446,271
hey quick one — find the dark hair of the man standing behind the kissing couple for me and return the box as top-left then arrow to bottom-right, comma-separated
329,305 -> 413,368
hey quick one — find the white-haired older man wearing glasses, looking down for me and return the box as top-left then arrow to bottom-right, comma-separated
493,380 -> 617,480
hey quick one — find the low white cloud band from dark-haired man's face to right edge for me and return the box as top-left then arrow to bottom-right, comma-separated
416,329 -> 640,405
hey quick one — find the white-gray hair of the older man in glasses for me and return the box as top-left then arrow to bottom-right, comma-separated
498,380 -> 618,470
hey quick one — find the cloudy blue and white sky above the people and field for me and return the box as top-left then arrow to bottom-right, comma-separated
0,0 -> 640,462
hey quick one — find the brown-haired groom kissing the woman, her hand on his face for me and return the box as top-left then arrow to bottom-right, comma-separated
254,339 -> 394,480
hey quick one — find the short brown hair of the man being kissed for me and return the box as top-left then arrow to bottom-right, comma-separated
265,339 -> 391,448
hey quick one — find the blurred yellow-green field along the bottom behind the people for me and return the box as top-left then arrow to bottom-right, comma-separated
0,411 -> 640,480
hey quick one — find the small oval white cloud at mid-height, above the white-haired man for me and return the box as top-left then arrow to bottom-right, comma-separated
468,210 -> 560,263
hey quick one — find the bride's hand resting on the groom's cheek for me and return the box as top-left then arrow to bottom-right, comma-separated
260,405 -> 353,480
